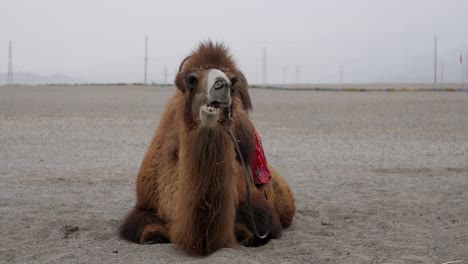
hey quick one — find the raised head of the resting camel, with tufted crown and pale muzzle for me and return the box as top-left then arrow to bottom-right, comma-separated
175,42 -> 251,127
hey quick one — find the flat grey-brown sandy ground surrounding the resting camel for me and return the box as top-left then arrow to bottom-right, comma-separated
0,86 -> 468,263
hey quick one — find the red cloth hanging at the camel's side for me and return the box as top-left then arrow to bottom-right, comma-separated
252,130 -> 271,185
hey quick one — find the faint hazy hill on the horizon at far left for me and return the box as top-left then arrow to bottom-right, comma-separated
0,72 -> 84,85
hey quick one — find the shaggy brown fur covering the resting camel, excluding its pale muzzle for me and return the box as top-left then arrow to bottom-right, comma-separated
120,42 -> 295,255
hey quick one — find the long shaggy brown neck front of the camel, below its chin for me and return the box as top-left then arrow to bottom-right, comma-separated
172,127 -> 237,254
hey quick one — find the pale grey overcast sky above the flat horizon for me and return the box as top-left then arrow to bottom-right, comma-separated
0,0 -> 468,83
